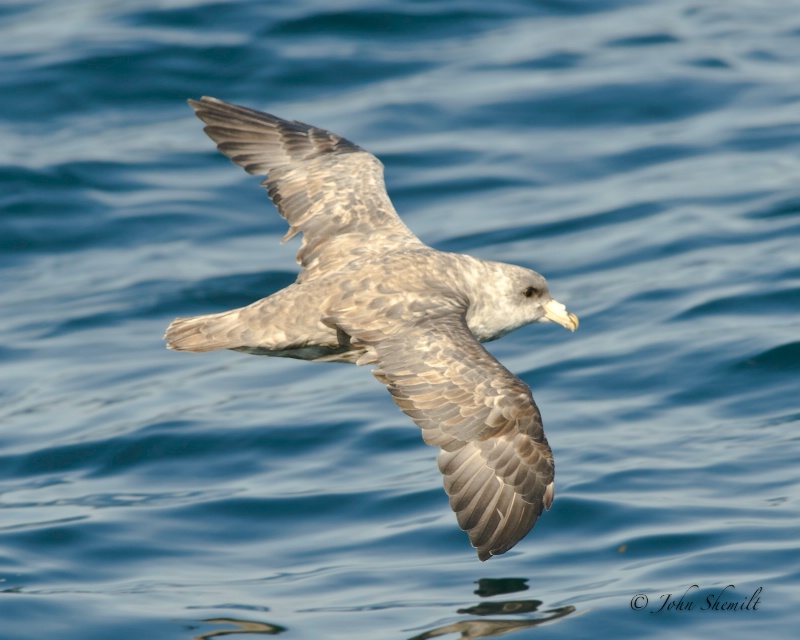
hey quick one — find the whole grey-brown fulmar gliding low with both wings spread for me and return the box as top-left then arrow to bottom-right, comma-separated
165,97 -> 578,560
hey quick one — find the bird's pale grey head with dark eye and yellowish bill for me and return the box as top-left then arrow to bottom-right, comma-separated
467,261 -> 578,342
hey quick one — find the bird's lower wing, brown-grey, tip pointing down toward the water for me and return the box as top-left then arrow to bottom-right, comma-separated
360,313 -> 555,560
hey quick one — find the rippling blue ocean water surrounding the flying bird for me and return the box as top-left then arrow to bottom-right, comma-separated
0,0 -> 800,640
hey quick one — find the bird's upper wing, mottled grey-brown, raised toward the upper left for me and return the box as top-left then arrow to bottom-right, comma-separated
189,97 -> 422,280
